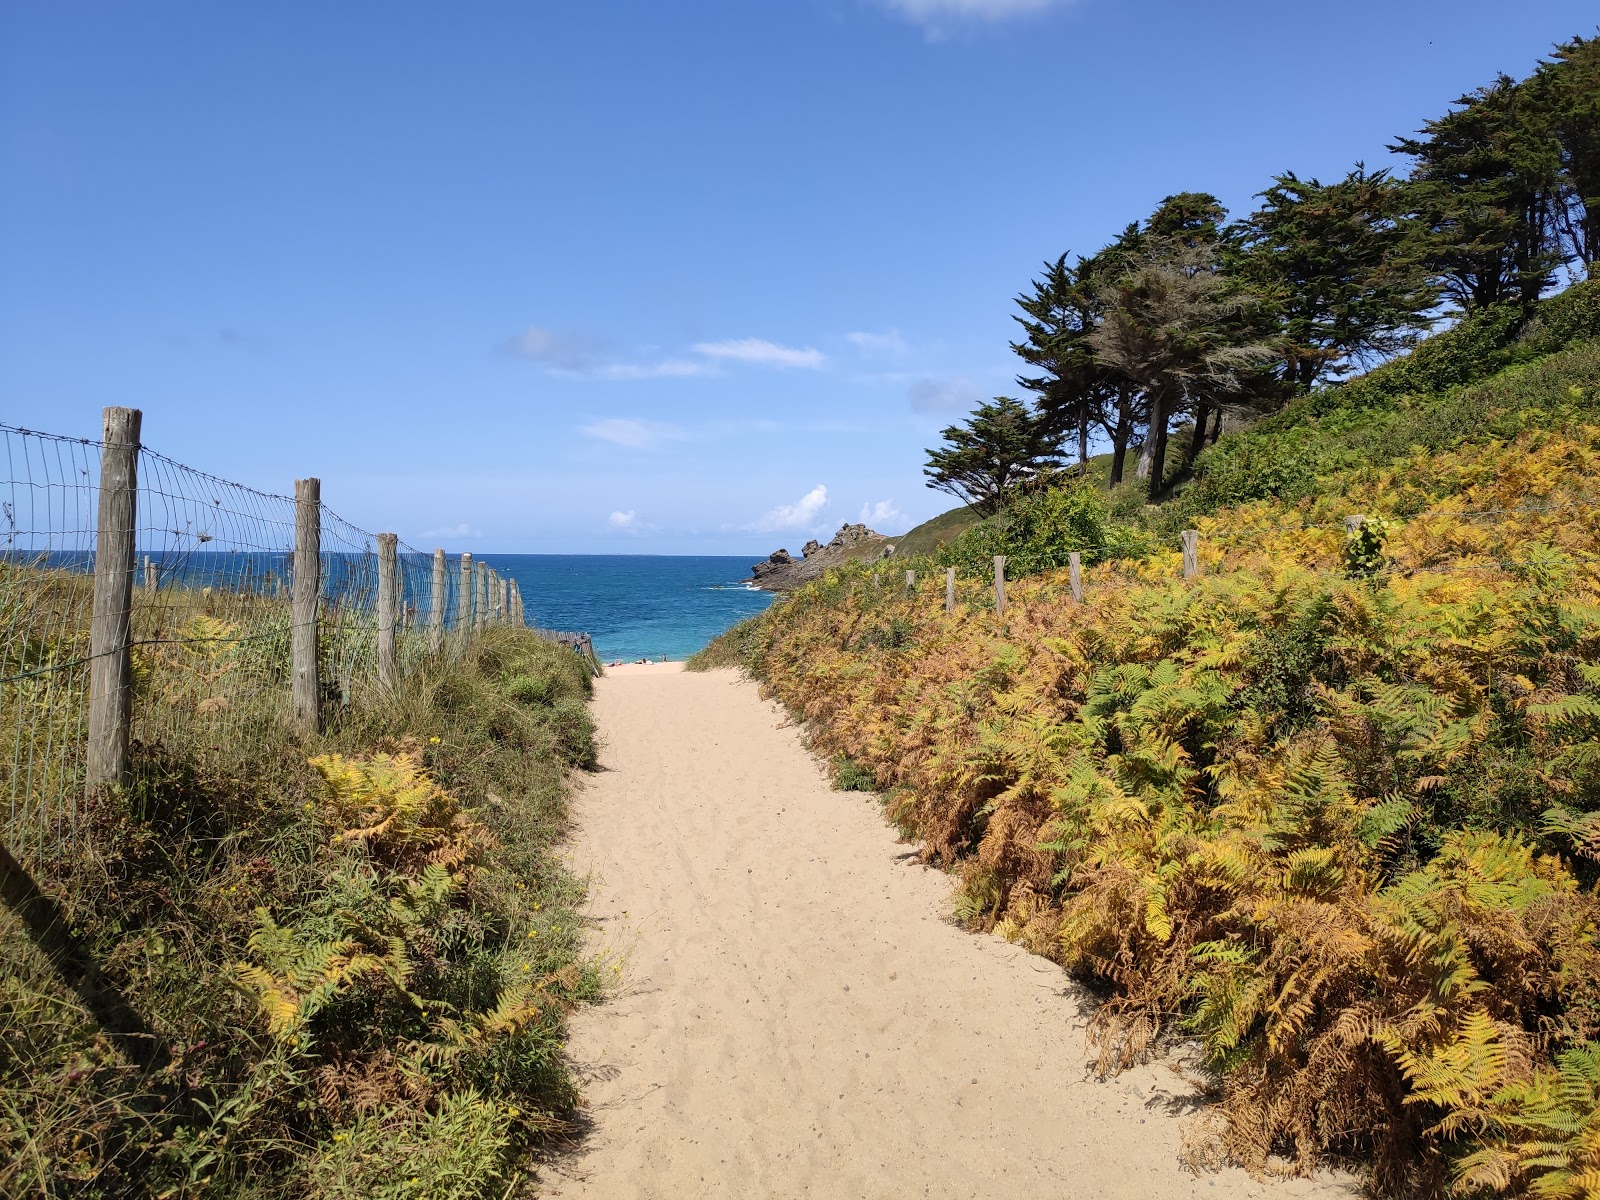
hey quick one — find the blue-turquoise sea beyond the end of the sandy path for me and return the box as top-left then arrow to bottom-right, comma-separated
482,554 -> 773,662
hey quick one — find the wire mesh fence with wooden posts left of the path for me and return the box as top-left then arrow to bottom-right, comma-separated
0,408 -> 544,861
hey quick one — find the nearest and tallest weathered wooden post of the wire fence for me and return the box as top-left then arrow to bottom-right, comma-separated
88,408 -> 142,787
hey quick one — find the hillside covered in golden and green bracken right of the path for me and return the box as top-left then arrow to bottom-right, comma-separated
702,285 -> 1600,1197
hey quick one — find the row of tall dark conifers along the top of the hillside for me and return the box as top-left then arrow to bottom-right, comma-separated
930,30 -> 1600,512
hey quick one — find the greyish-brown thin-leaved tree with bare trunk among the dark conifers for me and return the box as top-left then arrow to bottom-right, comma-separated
1088,235 -> 1278,502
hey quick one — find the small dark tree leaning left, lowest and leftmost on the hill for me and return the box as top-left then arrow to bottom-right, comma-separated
922,395 -> 1061,517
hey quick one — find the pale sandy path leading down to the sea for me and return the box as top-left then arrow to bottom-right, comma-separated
544,664 -> 1357,1200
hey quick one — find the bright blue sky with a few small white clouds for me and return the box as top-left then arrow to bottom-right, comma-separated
0,0 -> 1595,554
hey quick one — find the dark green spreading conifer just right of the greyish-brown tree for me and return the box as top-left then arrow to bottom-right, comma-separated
1229,163 -> 1438,392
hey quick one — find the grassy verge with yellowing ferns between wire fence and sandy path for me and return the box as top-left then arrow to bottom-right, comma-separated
0,604 -> 598,1198
